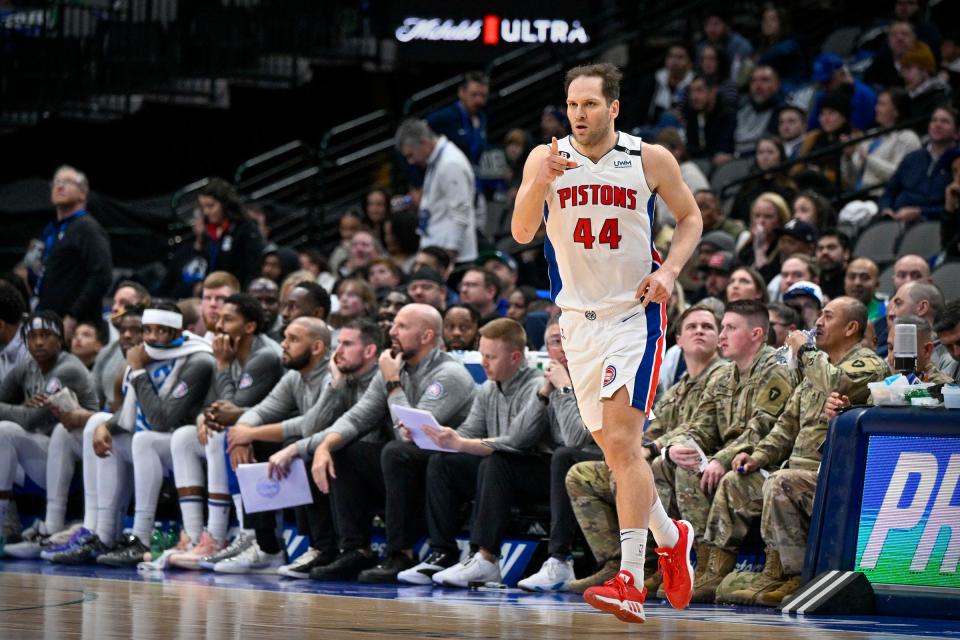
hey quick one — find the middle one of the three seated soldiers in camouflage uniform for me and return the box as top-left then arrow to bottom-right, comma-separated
653,300 -> 796,600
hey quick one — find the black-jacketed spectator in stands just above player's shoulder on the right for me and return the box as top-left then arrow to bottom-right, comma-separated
684,76 -> 736,166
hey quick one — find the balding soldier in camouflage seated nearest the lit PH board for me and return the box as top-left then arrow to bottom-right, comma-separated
695,297 -> 890,605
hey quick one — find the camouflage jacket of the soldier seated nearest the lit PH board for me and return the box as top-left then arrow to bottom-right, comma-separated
742,344 -> 890,470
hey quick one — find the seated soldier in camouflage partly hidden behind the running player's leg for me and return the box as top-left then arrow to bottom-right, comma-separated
566,304 -> 723,592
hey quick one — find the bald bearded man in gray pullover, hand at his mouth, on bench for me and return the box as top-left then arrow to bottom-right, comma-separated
310,304 -> 476,582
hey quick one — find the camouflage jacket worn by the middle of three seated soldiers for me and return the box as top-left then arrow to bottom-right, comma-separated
670,345 -> 797,469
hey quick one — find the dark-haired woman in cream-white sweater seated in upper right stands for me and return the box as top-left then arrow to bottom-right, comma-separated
843,87 -> 920,196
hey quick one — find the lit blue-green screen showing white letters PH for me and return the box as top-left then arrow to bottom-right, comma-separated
856,435 -> 960,589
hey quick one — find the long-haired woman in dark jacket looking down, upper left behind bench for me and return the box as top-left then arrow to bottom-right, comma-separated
197,178 -> 264,285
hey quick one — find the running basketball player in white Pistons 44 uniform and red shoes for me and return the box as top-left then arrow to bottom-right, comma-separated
512,64 -> 703,622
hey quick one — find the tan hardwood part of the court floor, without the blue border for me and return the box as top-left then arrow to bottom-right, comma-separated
0,572 -> 936,640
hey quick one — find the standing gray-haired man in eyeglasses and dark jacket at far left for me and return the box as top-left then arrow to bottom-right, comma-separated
34,165 -> 113,340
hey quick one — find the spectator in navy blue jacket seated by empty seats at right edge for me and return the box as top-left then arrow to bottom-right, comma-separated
878,107 -> 957,224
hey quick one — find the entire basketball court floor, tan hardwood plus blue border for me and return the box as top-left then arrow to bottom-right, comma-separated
0,561 -> 960,640
